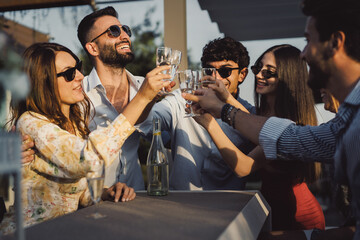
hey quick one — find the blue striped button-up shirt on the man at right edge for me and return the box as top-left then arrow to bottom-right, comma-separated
259,81 -> 360,239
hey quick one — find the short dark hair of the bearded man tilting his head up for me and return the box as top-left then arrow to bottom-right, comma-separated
78,7 -> 118,52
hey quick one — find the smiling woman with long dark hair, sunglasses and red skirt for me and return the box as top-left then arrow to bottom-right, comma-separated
197,44 -> 325,230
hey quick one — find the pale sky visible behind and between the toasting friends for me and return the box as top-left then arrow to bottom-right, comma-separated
5,0 -> 333,122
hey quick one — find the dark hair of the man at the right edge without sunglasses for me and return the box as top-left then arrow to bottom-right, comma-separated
302,0 -> 360,62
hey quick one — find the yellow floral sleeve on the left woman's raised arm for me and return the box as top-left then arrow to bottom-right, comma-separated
18,112 -> 134,179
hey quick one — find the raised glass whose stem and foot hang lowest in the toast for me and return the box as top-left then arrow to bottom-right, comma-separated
176,70 -> 199,118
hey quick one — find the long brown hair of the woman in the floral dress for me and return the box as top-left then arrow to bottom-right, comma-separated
11,43 -> 91,138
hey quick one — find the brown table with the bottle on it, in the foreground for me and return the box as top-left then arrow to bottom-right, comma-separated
5,191 -> 271,240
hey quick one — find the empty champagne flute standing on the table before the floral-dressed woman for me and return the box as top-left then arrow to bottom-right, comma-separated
86,159 -> 106,219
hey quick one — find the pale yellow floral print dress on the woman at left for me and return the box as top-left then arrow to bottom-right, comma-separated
0,112 -> 135,234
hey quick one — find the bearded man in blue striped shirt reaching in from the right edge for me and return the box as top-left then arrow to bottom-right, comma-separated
183,0 -> 360,239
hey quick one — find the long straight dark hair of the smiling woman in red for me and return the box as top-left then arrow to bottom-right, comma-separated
255,44 -> 321,182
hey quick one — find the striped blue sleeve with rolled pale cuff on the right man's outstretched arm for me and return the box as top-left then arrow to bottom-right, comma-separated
259,117 -> 343,163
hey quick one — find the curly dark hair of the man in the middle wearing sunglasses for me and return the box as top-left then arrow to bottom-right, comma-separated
201,37 -> 250,69
